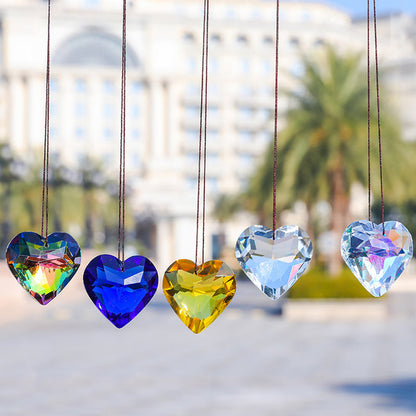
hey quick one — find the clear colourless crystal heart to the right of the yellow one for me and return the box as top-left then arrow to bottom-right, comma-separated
235,225 -> 313,299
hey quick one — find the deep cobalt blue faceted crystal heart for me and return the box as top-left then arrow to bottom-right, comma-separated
84,254 -> 158,328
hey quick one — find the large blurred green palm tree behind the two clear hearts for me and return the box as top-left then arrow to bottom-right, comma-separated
219,48 -> 415,275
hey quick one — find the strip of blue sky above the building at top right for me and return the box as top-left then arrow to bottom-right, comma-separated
325,0 -> 416,16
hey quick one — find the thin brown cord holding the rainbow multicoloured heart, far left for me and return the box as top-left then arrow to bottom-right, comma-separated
41,0 -> 51,246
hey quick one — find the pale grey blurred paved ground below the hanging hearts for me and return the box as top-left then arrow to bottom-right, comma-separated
0,258 -> 416,416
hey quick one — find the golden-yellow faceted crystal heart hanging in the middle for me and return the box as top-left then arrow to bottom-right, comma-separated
163,260 -> 236,334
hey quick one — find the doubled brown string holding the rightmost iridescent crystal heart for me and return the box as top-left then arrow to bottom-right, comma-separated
367,0 -> 385,234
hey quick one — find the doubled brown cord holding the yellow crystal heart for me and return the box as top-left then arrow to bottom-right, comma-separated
195,0 -> 209,272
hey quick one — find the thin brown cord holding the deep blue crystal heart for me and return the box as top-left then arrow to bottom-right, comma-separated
118,0 -> 127,271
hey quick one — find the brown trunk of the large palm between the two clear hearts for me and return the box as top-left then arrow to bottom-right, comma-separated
328,167 -> 350,276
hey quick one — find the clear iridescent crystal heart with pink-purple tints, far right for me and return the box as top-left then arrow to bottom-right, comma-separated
341,221 -> 413,297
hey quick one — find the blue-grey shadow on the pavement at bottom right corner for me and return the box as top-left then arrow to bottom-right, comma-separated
340,378 -> 416,414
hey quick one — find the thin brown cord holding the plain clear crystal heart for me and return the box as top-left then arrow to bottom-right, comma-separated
273,0 -> 280,240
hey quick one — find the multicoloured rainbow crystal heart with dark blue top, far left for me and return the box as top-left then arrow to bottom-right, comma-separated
6,232 -> 81,305
